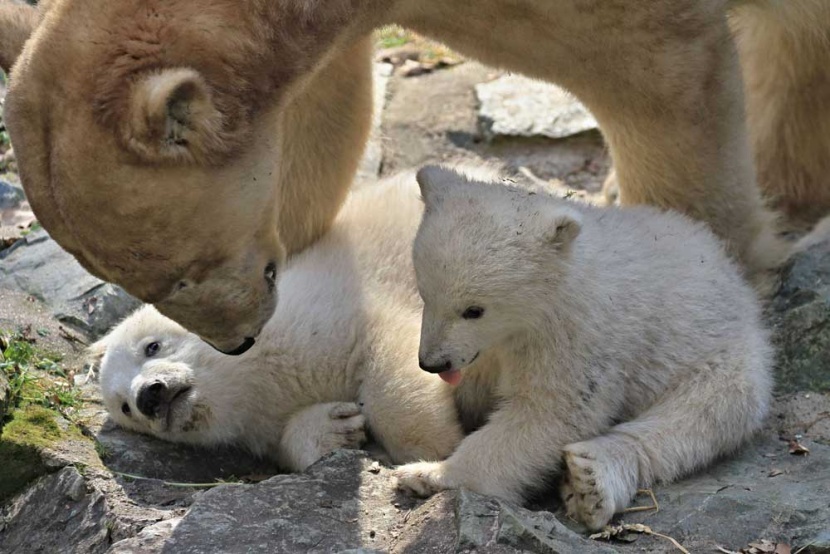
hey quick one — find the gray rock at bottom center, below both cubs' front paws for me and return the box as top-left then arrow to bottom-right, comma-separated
146,451 -> 613,554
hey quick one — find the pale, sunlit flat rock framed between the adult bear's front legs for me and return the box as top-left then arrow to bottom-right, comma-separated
475,75 -> 597,143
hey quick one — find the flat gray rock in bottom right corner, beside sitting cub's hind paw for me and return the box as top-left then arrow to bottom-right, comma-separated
624,432 -> 830,552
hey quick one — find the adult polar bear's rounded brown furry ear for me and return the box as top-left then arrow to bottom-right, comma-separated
123,68 -> 222,161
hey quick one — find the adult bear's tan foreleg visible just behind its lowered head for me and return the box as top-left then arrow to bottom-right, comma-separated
277,37 -> 372,255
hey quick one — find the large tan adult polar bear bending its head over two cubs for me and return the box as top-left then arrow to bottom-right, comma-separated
0,0 -> 830,353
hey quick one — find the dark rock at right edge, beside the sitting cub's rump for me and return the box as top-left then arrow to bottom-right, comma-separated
767,240 -> 830,392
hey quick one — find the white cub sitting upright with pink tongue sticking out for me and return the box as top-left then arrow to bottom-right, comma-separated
397,167 -> 772,529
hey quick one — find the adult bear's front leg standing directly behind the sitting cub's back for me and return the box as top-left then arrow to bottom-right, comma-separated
576,2 -> 786,276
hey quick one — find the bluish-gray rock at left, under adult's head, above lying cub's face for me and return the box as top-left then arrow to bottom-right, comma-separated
0,229 -> 141,338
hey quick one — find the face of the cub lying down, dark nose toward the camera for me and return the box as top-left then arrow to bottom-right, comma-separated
93,306 -> 221,440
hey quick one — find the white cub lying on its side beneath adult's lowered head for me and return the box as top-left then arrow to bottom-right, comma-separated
94,175 -> 462,470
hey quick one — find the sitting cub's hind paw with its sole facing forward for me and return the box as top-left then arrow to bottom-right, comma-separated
561,442 -> 616,530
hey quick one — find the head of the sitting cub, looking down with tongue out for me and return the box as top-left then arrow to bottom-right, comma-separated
413,163 -> 580,383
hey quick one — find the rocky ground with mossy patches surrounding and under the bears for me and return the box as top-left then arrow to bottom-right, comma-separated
0,35 -> 830,554
